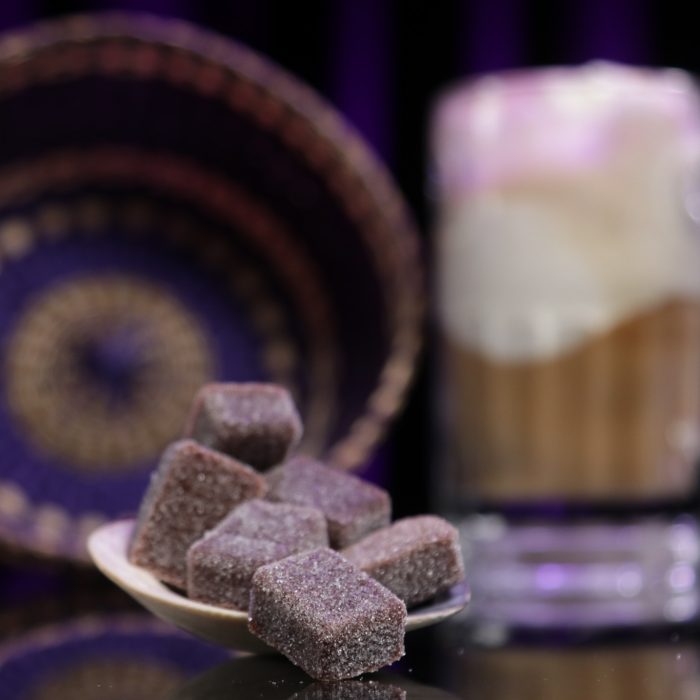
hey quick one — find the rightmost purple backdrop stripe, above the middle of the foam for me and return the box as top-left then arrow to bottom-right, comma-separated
561,0 -> 649,64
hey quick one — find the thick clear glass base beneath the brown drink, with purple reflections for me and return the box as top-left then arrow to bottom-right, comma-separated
457,514 -> 700,628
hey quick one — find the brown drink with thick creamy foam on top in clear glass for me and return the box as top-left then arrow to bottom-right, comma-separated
433,63 -> 700,505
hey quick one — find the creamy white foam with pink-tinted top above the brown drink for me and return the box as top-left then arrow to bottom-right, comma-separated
433,64 -> 700,361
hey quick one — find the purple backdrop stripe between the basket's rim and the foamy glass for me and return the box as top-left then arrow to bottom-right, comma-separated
329,0 -> 394,161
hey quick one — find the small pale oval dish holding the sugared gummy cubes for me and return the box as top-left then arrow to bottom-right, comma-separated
88,520 -> 469,652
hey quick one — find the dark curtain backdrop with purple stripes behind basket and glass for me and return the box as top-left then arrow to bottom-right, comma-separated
0,0 -> 700,515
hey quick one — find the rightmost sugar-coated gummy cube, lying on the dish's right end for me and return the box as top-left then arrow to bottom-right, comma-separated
341,515 -> 464,606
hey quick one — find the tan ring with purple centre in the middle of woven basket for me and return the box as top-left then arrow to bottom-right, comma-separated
6,275 -> 214,471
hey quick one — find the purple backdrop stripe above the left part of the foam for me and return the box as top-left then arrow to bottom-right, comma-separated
457,0 -> 527,74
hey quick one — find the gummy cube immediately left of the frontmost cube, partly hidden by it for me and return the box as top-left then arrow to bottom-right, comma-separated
187,534 -> 290,610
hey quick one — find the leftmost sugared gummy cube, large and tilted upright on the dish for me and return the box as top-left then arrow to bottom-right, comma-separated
129,440 -> 267,589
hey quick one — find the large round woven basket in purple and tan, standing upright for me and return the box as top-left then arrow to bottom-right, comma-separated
0,14 -> 422,560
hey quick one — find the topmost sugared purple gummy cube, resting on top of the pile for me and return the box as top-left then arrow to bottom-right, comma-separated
185,383 -> 302,469
